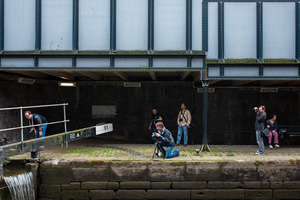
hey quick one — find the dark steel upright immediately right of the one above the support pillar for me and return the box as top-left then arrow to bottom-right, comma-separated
218,0 -> 224,60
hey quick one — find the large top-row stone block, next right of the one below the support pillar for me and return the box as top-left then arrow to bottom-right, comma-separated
221,162 -> 258,182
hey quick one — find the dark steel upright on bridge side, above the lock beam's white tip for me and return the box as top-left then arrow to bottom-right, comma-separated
110,0 -> 116,52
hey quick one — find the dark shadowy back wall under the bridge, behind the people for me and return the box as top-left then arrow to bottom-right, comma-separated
0,81 -> 300,144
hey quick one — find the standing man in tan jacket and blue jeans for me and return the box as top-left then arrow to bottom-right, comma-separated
176,103 -> 192,147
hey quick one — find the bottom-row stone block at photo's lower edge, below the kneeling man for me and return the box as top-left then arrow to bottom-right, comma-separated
147,190 -> 190,199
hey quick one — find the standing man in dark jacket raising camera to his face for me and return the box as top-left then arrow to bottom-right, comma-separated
253,106 -> 267,155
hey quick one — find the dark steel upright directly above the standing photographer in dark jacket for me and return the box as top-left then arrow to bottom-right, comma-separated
256,0 -> 263,60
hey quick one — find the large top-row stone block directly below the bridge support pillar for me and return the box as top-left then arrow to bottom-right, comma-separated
184,162 -> 221,181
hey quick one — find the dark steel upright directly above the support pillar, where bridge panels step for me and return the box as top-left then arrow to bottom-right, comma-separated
202,0 -> 208,51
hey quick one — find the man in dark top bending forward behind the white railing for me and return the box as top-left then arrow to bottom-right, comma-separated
24,111 -> 48,138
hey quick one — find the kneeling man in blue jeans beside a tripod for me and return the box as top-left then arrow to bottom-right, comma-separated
154,122 -> 179,158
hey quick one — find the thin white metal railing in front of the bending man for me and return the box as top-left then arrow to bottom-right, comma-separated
0,103 -> 70,148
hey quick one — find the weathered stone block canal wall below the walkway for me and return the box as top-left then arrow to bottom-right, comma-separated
38,160 -> 300,200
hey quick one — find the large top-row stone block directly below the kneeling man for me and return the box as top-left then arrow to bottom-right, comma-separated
148,162 -> 186,182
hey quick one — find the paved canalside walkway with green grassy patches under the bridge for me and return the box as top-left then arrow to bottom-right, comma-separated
10,137 -> 300,162
